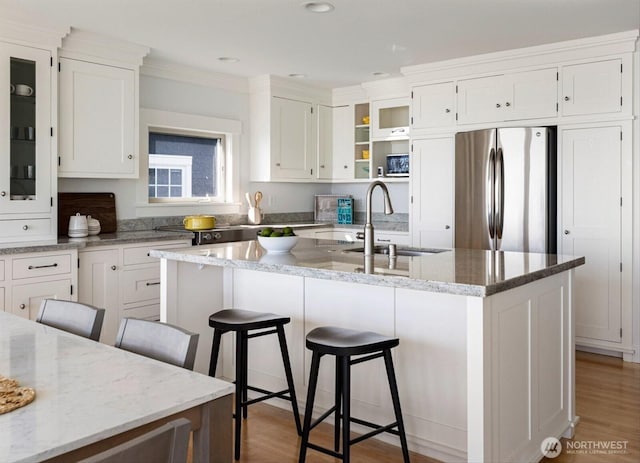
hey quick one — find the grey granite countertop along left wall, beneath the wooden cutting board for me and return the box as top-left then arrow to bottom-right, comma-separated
0,230 -> 193,255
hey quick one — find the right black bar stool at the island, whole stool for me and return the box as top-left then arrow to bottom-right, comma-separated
298,326 -> 409,463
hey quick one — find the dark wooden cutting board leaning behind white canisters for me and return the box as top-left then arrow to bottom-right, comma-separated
58,193 -> 118,236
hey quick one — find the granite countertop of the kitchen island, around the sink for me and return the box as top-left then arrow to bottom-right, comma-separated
151,238 -> 585,297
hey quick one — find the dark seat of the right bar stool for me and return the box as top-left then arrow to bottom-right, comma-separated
307,326 -> 400,356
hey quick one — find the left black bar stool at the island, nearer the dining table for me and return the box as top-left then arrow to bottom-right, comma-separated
209,309 -> 302,460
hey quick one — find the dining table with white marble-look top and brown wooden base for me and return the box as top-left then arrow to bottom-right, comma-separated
0,311 -> 234,463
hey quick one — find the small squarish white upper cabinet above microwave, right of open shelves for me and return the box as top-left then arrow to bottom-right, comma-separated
370,98 -> 410,140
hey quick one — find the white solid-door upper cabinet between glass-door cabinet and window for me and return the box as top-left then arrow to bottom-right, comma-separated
58,31 -> 149,178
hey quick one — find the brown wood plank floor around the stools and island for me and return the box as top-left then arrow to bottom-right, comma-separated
198,352 -> 640,463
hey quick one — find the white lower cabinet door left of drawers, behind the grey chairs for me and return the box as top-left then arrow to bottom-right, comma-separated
78,249 -> 120,345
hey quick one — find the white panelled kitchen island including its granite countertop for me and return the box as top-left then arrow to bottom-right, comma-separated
152,239 -> 584,462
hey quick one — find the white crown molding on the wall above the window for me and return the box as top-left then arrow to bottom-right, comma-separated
140,56 -> 249,93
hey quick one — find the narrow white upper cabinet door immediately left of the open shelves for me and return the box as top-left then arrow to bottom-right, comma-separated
331,106 -> 354,180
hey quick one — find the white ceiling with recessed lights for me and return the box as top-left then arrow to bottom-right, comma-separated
0,0 -> 640,87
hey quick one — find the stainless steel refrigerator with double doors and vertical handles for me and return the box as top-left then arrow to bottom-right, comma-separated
455,127 -> 557,253
